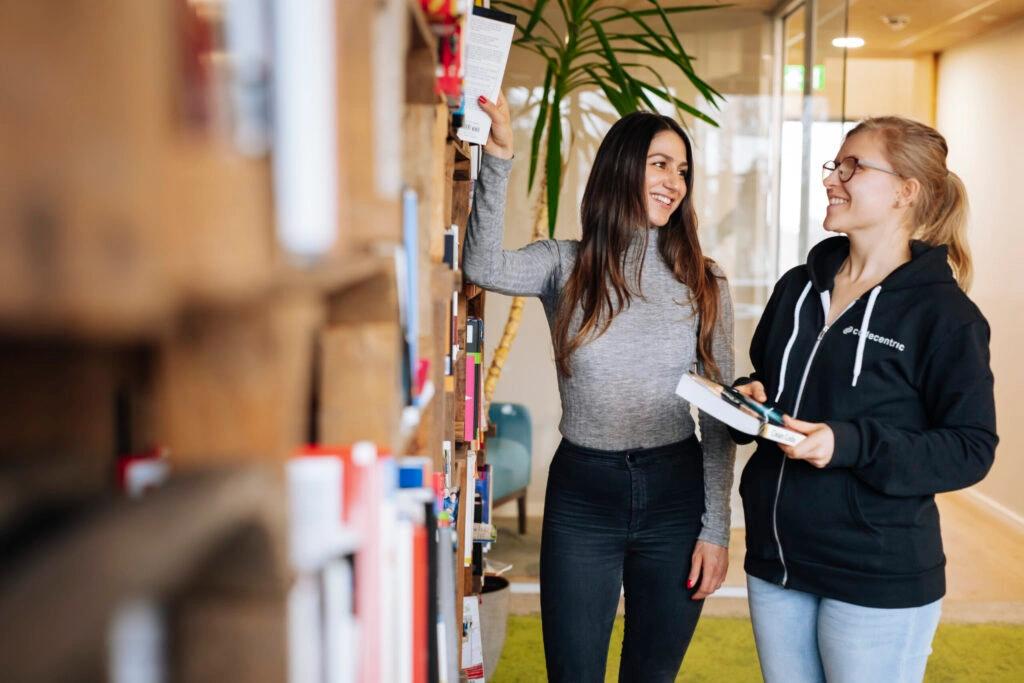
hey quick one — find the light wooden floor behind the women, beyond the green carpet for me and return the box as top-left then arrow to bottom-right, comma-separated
490,492 -> 1024,624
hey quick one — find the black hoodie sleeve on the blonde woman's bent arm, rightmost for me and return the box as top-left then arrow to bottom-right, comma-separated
826,321 -> 998,496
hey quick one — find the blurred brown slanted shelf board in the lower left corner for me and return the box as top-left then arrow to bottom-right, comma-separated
0,468 -> 288,681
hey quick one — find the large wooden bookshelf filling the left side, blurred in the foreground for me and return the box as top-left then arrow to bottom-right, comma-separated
0,0 -> 495,682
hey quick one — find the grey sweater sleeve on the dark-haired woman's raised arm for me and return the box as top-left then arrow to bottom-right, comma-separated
463,154 -> 561,296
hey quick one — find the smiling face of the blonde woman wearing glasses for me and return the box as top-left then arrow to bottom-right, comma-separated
823,132 -> 904,234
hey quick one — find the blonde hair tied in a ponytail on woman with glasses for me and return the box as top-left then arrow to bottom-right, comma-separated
847,116 -> 973,291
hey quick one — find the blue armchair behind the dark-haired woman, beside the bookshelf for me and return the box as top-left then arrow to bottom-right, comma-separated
487,403 -> 534,533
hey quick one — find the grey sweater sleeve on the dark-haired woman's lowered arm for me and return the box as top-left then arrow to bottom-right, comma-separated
698,269 -> 736,548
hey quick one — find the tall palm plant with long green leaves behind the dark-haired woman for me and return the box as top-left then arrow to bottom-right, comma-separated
484,0 -> 725,402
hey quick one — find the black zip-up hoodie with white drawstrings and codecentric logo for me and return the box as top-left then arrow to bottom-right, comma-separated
737,237 -> 998,608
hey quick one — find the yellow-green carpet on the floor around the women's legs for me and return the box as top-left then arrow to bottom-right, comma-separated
487,616 -> 1024,683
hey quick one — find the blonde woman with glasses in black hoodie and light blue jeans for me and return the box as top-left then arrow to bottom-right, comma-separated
737,117 -> 998,683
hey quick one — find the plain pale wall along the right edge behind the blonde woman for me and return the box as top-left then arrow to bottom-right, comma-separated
936,22 -> 1024,515
